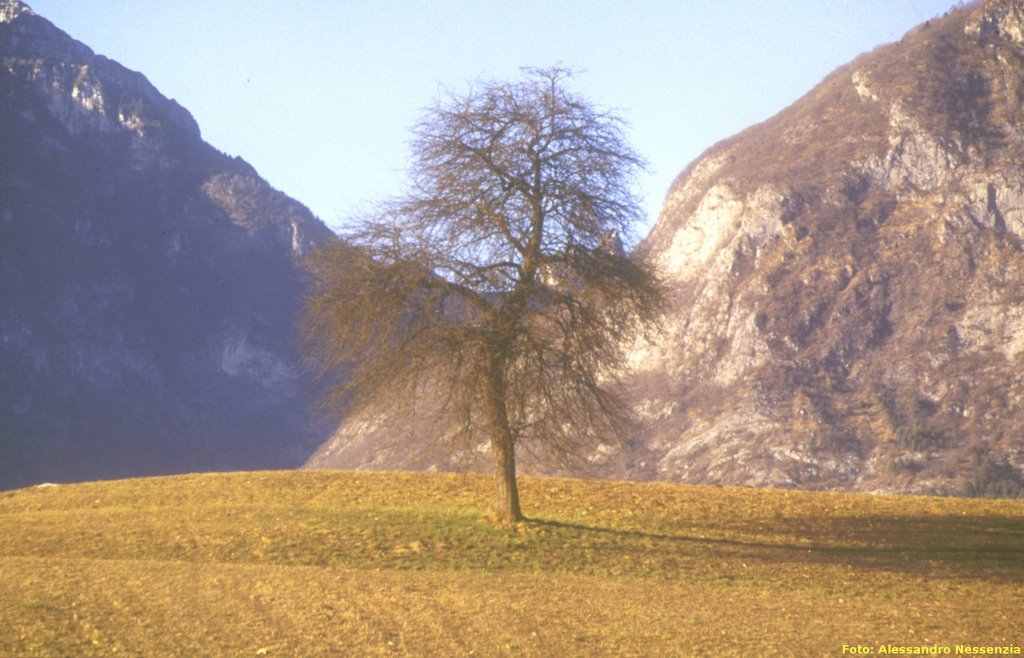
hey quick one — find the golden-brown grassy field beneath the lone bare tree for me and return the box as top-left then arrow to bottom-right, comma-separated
0,471 -> 1024,656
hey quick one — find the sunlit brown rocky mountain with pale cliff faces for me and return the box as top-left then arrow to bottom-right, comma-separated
308,0 -> 1024,495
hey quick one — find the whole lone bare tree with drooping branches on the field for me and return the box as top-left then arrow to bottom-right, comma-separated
305,68 -> 663,524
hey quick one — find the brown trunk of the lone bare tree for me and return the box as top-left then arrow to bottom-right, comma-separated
485,360 -> 523,526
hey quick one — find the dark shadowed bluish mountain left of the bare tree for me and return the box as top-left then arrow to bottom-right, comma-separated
0,0 -> 332,487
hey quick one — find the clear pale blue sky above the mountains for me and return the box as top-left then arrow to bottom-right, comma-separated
27,0 -> 953,233
